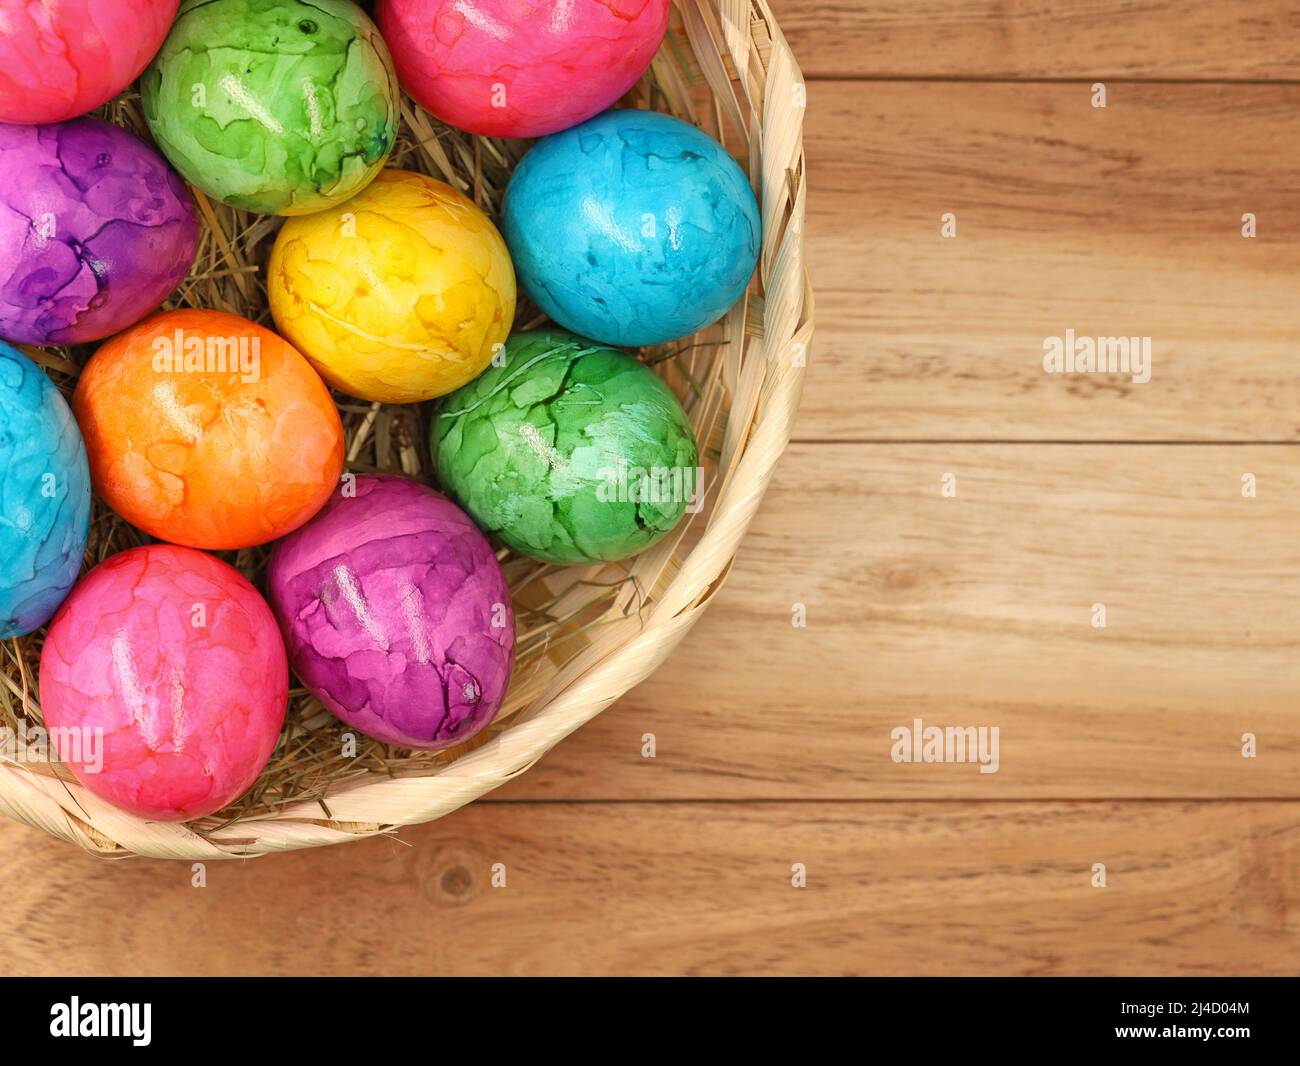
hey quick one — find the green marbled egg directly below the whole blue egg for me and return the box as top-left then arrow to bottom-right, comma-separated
430,330 -> 703,563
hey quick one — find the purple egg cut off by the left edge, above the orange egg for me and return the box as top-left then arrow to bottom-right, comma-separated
0,117 -> 199,345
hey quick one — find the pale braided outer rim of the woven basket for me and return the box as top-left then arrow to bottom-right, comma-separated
0,0 -> 814,861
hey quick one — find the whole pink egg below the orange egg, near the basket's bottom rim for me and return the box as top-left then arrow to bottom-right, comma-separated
40,545 -> 289,822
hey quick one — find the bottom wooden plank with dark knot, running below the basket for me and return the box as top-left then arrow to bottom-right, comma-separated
0,802 -> 1300,976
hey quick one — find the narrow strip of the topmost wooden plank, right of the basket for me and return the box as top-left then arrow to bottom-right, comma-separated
771,0 -> 1300,81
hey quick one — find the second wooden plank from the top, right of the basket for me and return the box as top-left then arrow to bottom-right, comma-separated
796,82 -> 1300,441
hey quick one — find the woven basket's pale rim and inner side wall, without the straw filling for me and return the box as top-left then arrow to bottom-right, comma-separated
0,0 -> 813,861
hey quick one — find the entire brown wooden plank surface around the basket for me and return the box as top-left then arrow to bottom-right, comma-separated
0,0 -> 1300,974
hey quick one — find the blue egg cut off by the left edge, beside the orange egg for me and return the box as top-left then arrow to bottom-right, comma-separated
0,341 -> 90,640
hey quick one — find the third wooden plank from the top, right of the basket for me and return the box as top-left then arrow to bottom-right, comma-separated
495,445 -> 1300,800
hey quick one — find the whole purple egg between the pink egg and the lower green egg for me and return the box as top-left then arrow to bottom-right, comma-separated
267,475 -> 515,749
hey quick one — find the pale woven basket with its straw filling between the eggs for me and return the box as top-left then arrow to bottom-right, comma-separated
0,0 -> 813,861
